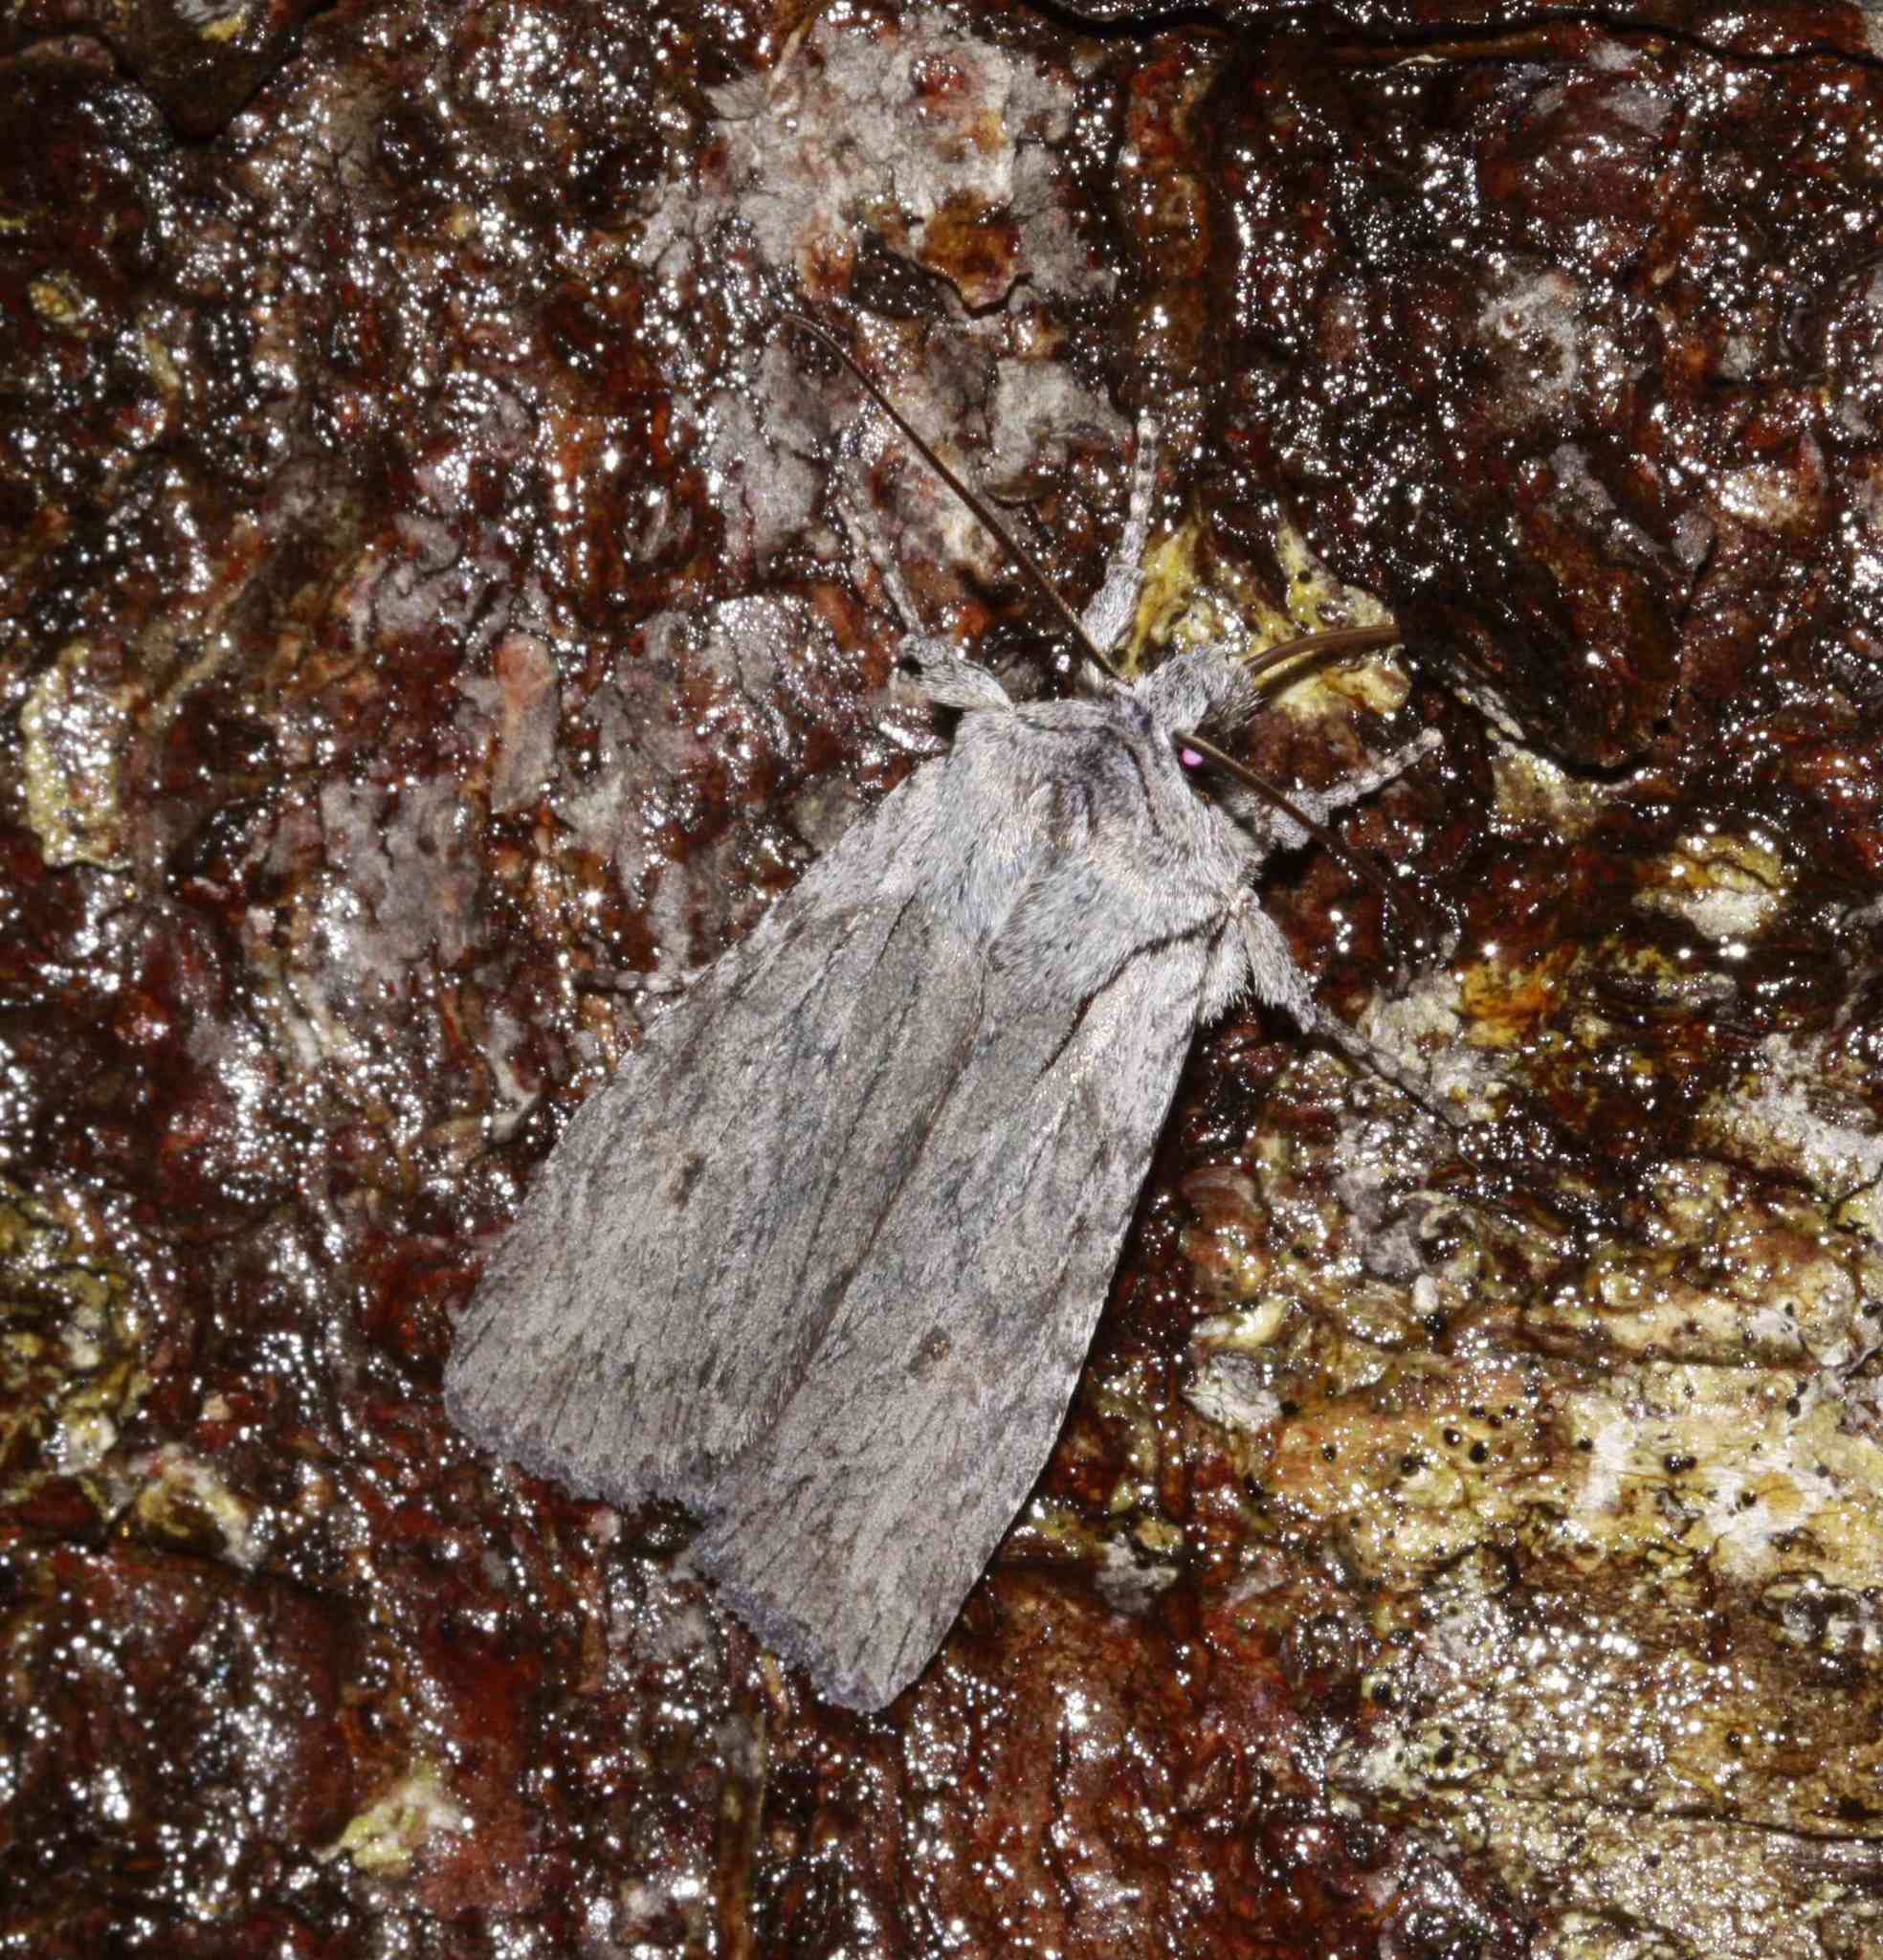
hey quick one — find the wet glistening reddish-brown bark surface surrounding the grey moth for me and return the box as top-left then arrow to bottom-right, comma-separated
0,0 -> 1883,1960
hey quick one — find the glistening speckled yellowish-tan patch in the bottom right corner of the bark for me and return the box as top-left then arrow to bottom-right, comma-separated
1337,1481 -> 1879,1956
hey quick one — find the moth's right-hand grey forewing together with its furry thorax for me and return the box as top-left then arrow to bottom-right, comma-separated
699,681 -> 1277,1707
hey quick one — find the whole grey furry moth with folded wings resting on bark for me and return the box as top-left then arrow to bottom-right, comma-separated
445,329 -> 1436,1709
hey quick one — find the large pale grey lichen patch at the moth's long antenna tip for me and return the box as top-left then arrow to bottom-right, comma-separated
674,10 -> 1124,611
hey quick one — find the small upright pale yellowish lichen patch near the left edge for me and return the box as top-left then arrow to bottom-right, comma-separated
19,639 -> 133,870
